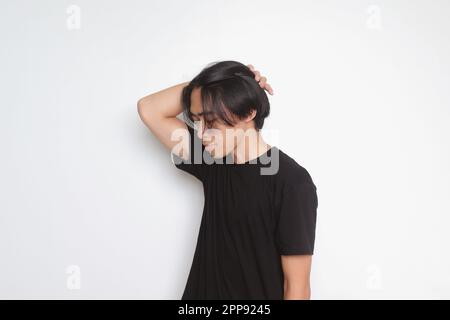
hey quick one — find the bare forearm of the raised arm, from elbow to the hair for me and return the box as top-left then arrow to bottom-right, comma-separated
138,82 -> 189,119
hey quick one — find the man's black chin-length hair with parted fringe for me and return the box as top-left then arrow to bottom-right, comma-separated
181,61 -> 270,130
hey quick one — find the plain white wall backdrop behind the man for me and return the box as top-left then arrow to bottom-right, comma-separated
0,0 -> 450,299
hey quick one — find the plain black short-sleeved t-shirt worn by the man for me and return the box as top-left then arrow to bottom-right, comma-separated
172,126 -> 318,300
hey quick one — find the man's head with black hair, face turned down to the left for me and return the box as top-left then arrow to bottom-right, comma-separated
182,61 -> 270,158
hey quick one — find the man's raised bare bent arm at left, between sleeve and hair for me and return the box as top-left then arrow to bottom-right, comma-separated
137,82 -> 189,159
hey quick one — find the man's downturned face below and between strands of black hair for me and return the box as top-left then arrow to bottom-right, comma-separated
191,88 -> 256,158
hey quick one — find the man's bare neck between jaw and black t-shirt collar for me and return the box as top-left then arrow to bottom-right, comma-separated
232,131 -> 271,164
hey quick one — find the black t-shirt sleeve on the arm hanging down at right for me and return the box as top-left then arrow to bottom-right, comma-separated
275,183 -> 318,255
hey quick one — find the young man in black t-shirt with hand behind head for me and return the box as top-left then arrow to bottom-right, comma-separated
138,61 -> 318,300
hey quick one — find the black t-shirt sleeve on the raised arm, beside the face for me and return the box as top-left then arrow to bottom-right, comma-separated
171,125 -> 207,181
